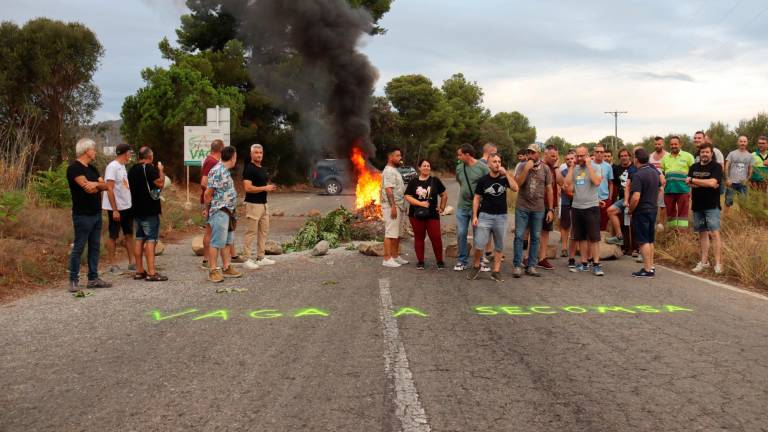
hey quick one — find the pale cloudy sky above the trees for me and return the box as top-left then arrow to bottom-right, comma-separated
0,0 -> 768,143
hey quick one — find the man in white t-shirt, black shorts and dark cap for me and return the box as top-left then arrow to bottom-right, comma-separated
101,144 -> 136,273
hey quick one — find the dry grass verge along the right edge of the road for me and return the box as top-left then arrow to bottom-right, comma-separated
656,197 -> 768,292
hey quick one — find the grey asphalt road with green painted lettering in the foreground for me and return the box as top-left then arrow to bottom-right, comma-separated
0,177 -> 768,431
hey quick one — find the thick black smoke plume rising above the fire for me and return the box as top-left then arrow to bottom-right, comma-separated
224,0 -> 378,158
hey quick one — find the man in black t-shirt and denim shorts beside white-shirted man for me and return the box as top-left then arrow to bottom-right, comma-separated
128,146 -> 168,282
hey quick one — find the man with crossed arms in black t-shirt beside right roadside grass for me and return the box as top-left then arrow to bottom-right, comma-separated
685,142 -> 723,274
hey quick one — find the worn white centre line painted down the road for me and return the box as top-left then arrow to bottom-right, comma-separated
379,279 -> 432,432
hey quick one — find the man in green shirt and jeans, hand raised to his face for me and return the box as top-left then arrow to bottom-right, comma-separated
453,144 -> 490,271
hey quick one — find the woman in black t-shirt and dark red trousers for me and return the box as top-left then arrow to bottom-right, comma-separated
405,159 -> 448,270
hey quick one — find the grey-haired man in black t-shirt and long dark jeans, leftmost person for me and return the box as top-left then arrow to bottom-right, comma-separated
67,138 -> 112,292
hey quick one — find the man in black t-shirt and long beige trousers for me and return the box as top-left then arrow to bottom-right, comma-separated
243,144 -> 277,270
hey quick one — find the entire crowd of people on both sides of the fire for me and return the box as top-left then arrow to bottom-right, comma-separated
67,131 -> 768,292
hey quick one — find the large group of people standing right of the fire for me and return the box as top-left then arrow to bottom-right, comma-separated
381,131 -> 768,281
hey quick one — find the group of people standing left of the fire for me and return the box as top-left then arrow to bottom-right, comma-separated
67,139 -> 276,292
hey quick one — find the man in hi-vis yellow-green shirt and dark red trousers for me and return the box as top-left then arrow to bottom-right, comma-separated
661,136 -> 694,229
